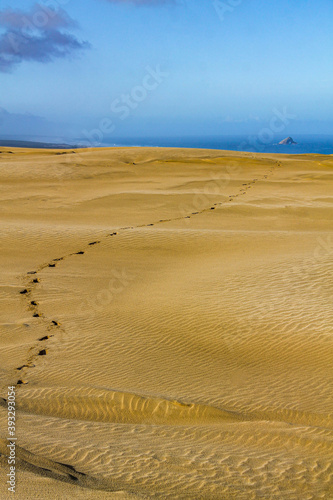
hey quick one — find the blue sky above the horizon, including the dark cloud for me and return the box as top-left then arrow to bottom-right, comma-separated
0,0 -> 333,145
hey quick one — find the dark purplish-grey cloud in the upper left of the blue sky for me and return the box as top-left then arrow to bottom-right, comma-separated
0,3 -> 90,72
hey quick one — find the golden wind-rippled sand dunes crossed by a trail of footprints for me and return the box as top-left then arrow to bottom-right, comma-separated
0,148 -> 333,500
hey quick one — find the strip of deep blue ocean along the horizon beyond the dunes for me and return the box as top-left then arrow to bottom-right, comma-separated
100,135 -> 333,155
